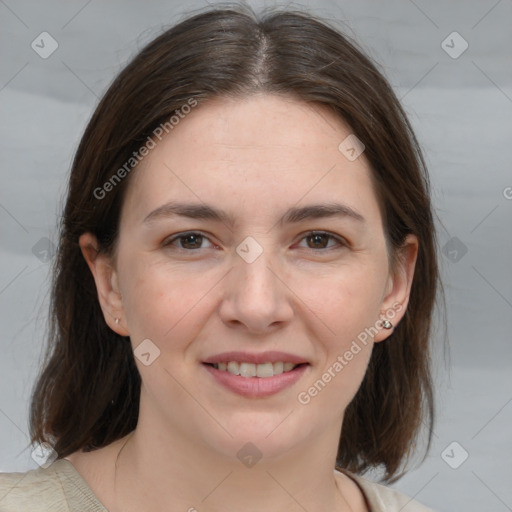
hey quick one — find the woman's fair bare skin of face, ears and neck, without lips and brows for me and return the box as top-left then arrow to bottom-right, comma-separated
72,95 -> 418,512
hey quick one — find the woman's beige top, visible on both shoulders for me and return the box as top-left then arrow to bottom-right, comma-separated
0,459 -> 434,512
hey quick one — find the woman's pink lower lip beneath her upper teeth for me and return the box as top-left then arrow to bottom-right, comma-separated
202,362 -> 309,398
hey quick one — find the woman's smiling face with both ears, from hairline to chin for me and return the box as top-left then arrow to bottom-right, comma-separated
81,95 -> 416,464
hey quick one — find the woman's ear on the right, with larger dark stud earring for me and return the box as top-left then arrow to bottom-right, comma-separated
374,235 -> 419,343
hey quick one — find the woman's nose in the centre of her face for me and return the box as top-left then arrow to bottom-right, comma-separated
219,242 -> 293,334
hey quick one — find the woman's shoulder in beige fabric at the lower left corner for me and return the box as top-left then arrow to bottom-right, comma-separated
0,459 -> 106,512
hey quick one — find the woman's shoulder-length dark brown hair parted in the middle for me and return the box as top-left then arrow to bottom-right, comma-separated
30,7 -> 440,483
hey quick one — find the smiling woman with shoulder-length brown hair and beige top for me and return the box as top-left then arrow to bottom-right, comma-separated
0,7 -> 439,512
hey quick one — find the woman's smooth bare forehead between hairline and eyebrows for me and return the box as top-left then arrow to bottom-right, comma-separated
125,95 -> 379,226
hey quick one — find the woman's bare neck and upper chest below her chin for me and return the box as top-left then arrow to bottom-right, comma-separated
114,402 -> 351,512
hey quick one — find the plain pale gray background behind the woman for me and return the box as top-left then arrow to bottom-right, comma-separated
0,0 -> 512,512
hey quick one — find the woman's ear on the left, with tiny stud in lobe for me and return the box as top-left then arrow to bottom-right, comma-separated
78,233 -> 129,336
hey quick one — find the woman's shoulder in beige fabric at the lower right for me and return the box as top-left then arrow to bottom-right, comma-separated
336,470 -> 434,512
